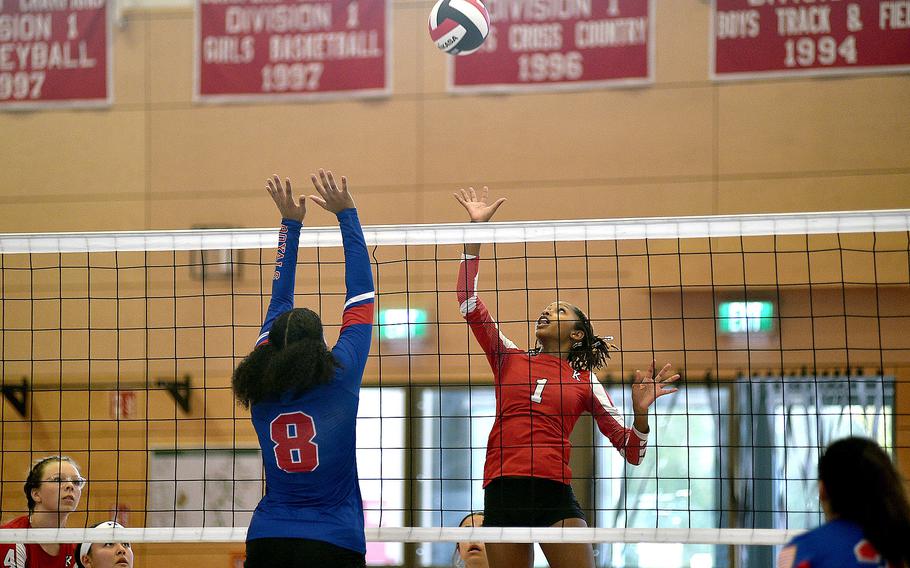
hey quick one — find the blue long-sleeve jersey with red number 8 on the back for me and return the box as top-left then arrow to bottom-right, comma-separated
247,209 -> 375,553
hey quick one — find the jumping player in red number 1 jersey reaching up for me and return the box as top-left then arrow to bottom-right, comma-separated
455,187 -> 679,568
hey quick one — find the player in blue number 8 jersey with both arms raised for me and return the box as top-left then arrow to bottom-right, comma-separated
233,170 -> 375,568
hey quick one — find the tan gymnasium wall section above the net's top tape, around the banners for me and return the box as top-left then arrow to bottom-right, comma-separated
0,0 -> 910,232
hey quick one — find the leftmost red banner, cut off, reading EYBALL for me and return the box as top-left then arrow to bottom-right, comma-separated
0,0 -> 113,110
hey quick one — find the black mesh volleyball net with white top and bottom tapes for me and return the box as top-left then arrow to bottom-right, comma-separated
0,210 -> 910,567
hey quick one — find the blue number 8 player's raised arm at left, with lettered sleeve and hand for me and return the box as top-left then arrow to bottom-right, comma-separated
256,175 -> 306,345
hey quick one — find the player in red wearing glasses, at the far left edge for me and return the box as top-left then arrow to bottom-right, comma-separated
0,456 -> 85,568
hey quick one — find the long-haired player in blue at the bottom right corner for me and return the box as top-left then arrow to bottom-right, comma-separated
777,438 -> 910,568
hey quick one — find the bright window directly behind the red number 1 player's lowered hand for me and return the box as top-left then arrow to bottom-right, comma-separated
594,384 -> 730,568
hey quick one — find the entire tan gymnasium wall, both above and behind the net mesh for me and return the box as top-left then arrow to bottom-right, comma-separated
0,0 -> 910,568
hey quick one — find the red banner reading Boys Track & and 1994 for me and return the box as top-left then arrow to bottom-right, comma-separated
711,0 -> 910,80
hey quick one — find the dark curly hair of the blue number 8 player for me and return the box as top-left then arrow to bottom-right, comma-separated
231,308 -> 339,408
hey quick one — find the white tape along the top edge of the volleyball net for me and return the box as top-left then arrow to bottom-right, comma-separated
0,209 -> 910,254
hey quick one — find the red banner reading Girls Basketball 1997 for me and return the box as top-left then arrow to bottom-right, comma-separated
195,0 -> 391,102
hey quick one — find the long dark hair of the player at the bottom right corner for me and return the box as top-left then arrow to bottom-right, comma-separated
818,437 -> 910,567
